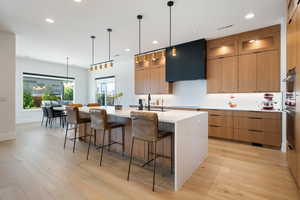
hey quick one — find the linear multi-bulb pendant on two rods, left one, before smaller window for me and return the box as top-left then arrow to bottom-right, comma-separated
89,28 -> 114,71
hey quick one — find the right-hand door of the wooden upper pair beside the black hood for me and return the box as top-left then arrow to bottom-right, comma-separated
221,56 -> 238,93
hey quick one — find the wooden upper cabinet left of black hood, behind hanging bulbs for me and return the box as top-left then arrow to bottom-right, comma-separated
135,51 -> 172,94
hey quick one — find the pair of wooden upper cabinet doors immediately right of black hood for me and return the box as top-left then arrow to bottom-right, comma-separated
207,56 -> 238,93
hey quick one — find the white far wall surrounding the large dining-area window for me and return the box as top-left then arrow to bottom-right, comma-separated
16,57 -> 88,123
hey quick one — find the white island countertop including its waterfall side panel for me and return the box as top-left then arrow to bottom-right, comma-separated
79,106 -> 208,191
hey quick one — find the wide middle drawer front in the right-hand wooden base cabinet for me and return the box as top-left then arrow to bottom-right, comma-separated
234,117 -> 281,134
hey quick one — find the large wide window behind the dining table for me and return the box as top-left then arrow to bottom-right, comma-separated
23,73 -> 75,109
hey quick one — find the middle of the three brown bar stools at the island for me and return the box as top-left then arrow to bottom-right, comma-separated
86,109 -> 125,166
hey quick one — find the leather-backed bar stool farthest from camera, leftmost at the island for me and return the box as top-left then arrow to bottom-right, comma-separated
64,106 -> 91,153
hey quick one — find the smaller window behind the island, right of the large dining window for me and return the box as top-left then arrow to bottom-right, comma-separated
96,76 -> 115,106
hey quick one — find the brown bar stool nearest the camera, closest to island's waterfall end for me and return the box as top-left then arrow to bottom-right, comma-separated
127,112 -> 174,192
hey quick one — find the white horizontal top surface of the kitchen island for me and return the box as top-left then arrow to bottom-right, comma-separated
79,106 -> 205,123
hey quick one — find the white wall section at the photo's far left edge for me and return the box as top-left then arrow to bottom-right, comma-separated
0,32 -> 16,141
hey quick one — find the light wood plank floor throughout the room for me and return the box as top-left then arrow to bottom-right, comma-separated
0,124 -> 298,200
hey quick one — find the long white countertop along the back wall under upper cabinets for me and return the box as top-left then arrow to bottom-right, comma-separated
130,105 -> 283,112
